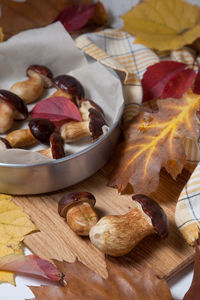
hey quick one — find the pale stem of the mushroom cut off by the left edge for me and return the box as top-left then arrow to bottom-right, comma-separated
0,102 -> 14,133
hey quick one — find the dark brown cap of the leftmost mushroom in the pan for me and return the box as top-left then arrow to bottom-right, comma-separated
0,90 -> 28,120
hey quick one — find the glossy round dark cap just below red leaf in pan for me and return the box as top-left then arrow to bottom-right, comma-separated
28,118 -> 56,144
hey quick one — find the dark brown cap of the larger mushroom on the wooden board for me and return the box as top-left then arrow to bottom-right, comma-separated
132,194 -> 168,239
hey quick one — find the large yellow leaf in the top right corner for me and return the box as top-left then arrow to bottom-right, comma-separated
122,0 -> 200,51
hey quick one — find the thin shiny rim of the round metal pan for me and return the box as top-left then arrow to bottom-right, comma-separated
0,94 -> 125,168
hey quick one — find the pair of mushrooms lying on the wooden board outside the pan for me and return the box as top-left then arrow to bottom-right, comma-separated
58,192 -> 168,256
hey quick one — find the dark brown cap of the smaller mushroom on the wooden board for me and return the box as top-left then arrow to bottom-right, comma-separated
58,192 -> 96,217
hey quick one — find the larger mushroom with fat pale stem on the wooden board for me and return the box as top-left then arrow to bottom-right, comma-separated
89,194 -> 168,256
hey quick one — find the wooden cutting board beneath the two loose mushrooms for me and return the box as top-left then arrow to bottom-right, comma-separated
14,170 -> 194,279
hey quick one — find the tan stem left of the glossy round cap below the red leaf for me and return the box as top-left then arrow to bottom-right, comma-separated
6,128 -> 37,148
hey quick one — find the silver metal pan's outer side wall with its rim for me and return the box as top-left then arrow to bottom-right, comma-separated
0,101 -> 124,195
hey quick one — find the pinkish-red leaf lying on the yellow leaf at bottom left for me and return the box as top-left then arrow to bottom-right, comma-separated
0,254 -> 64,283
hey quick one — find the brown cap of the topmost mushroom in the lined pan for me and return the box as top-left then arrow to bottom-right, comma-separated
26,65 -> 53,88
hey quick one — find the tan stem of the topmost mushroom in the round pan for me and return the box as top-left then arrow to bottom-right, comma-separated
10,73 -> 44,103
